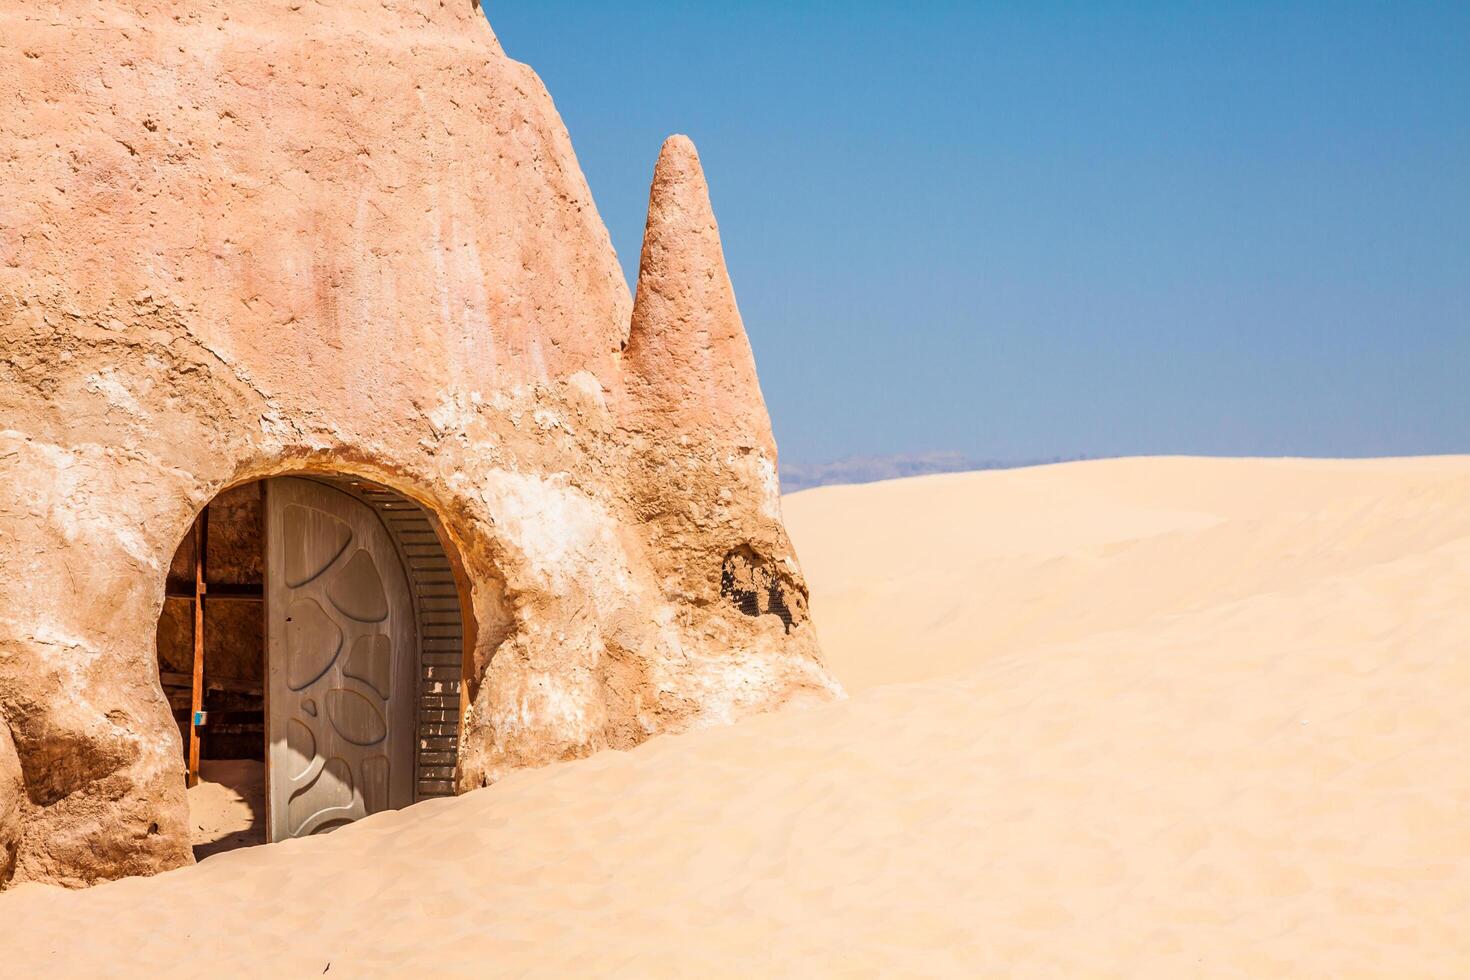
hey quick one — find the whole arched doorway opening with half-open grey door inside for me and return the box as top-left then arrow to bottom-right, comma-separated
157,475 -> 470,857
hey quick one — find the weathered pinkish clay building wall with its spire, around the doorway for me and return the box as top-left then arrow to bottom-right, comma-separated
0,0 -> 836,884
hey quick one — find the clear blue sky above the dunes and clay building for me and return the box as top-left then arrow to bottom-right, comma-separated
488,0 -> 1470,461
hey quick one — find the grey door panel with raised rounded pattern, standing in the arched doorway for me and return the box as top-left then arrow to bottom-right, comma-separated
266,478 -> 419,840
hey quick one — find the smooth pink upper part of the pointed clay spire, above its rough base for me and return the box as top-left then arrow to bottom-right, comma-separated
625,137 -> 775,455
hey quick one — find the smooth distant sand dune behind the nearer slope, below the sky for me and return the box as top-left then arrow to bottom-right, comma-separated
785,457 -> 1470,692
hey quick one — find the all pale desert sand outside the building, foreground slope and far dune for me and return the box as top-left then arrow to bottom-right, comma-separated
0,458 -> 1470,977
